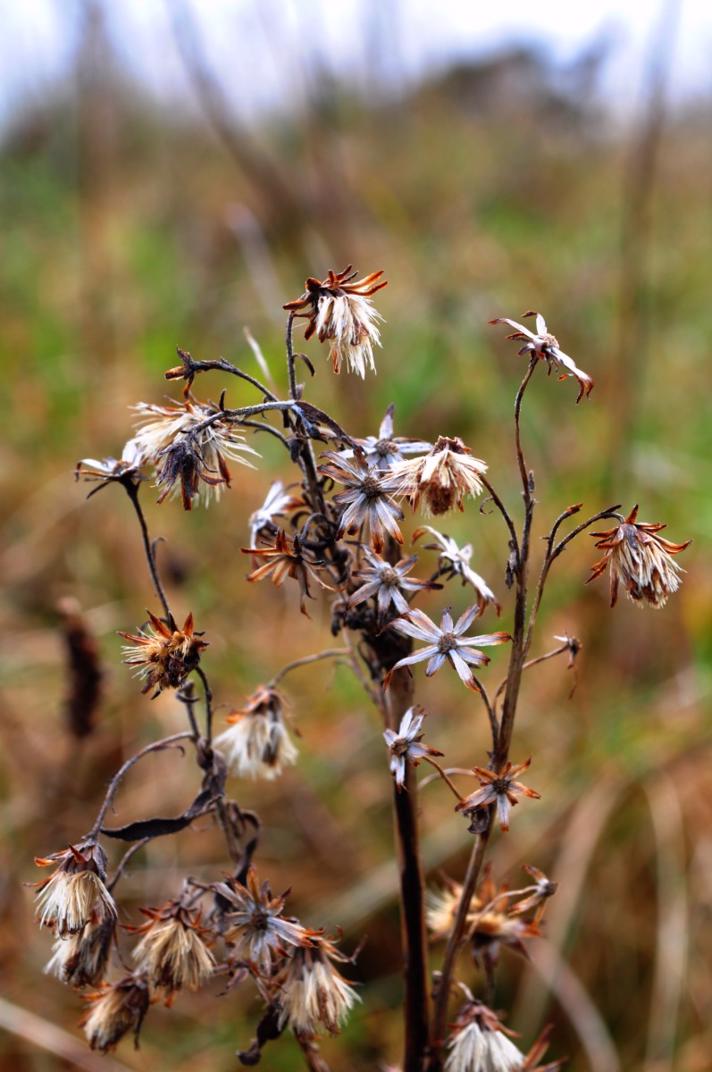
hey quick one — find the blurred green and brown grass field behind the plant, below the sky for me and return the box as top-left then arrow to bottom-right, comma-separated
0,23 -> 712,1072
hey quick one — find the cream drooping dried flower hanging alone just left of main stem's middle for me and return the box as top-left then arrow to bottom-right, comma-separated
214,685 -> 299,780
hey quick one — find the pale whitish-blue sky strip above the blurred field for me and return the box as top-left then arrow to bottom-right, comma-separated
0,0 -> 712,126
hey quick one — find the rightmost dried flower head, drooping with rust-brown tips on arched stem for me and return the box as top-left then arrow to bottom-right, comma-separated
587,505 -> 691,608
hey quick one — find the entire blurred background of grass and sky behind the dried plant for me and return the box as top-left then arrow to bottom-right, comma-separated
0,0 -> 712,1072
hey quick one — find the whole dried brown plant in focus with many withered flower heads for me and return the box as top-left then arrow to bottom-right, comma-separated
38,267 -> 686,1072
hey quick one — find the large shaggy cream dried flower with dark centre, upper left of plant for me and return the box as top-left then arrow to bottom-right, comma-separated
127,399 -> 259,510
